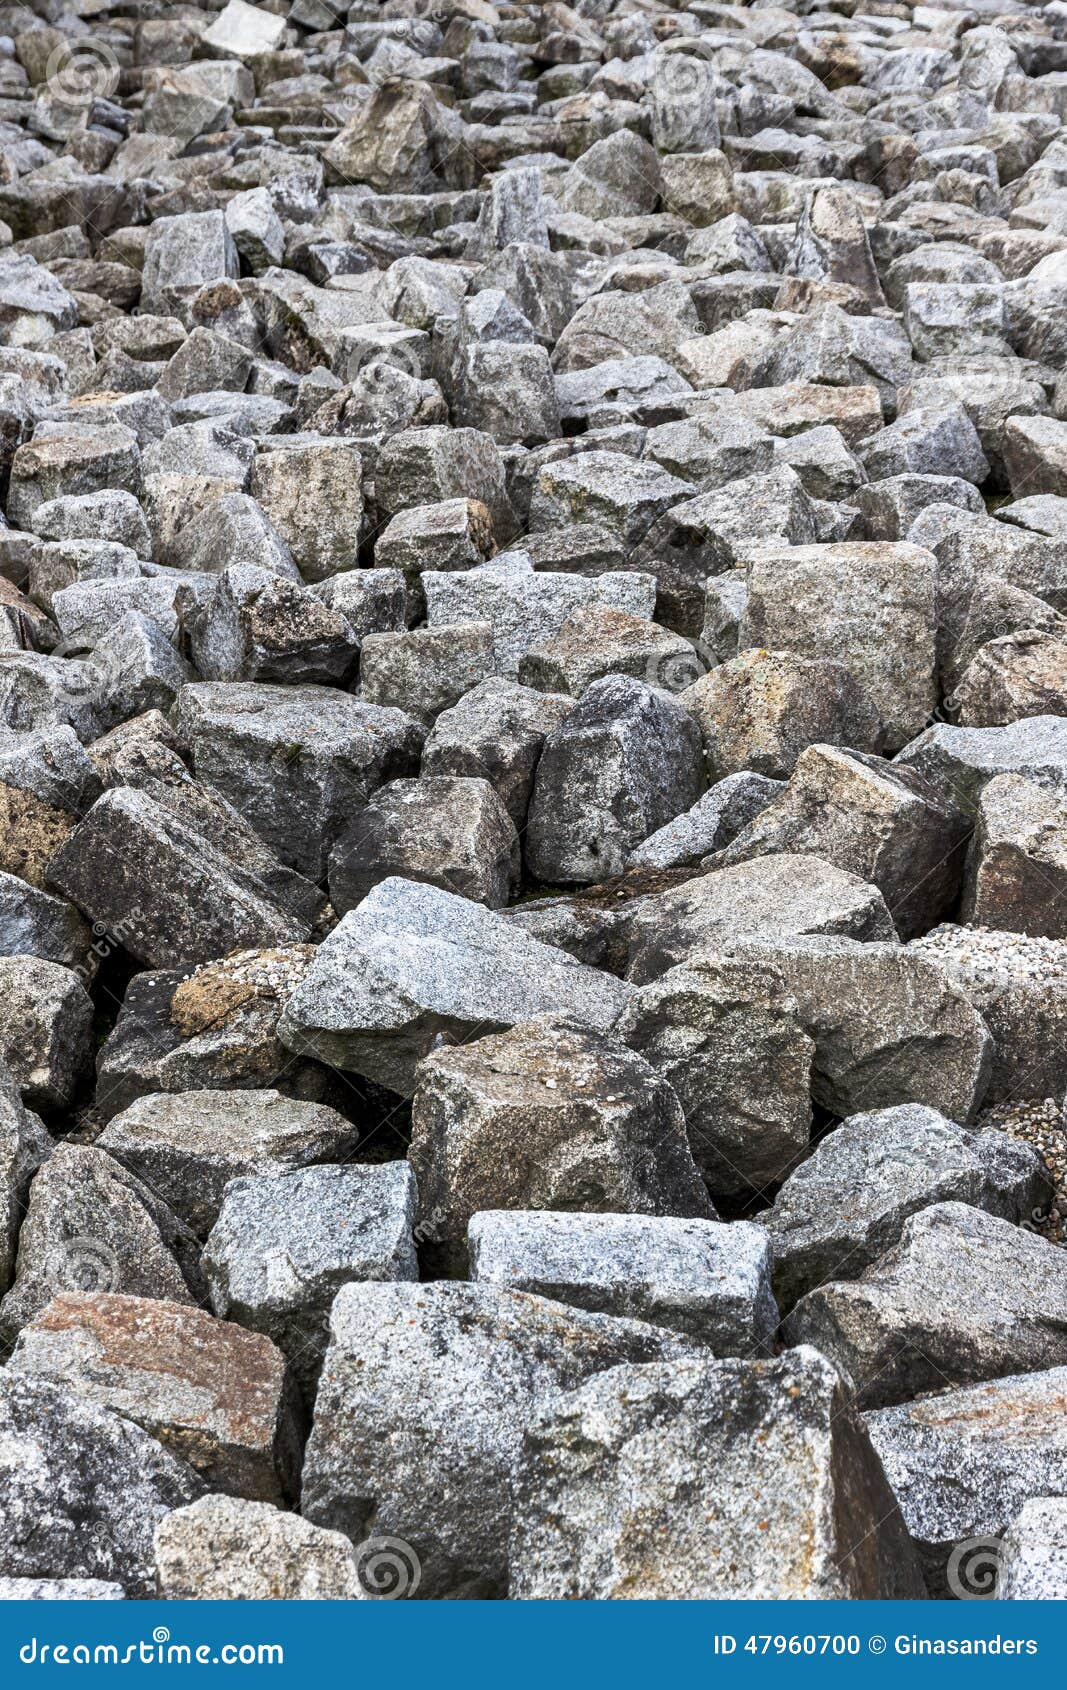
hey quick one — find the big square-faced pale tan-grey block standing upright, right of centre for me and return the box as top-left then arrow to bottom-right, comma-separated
739,541 -> 937,750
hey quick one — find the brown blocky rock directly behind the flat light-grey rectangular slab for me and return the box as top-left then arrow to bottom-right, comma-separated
409,1016 -> 712,1278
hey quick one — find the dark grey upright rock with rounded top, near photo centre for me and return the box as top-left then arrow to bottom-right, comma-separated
526,676 -> 703,884
